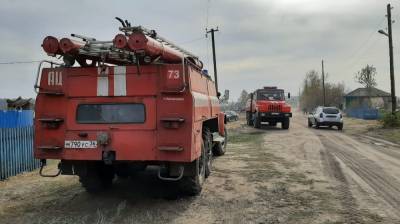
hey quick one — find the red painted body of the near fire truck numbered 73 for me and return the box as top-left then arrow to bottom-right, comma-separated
34,64 -> 220,162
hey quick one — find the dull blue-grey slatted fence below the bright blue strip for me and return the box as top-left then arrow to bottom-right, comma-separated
0,126 -> 40,180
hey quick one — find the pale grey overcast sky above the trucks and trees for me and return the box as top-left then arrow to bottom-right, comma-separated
0,0 -> 400,100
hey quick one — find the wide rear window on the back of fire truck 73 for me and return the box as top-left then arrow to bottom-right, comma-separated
76,103 -> 146,124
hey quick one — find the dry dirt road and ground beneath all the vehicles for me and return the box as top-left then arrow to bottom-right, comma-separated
0,115 -> 400,224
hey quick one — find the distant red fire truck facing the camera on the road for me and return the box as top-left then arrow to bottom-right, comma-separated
246,87 -> 292,129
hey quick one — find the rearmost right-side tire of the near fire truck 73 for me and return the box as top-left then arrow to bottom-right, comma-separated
179,144 -> 207,196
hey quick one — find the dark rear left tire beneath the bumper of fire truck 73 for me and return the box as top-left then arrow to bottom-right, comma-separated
79,164 -> 114,193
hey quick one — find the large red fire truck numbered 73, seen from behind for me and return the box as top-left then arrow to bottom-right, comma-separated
34,20 -> 227,195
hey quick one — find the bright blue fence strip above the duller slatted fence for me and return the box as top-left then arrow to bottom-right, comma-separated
0,110 -> 33,128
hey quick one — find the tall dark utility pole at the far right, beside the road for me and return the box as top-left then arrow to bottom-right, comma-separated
387,4 -> 397,114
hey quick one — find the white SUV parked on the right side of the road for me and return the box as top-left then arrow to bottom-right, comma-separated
308,106 -> 343,130
